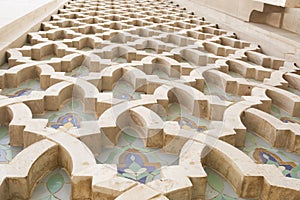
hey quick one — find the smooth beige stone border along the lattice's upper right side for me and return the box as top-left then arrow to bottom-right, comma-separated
174,0 -> 300,65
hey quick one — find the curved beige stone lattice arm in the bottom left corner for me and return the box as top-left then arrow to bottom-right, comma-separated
0,140 -> 58,199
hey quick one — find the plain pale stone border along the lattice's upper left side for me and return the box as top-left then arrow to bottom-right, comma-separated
0,0 -> 66,64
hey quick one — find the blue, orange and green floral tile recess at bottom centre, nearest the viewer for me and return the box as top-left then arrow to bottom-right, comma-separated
96,129 -> 178,183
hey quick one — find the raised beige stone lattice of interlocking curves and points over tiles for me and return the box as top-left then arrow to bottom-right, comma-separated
0,0 -> 300,200
